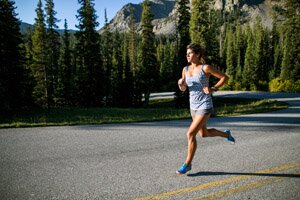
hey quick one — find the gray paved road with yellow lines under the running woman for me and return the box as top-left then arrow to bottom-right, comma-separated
0,92 -> 300,200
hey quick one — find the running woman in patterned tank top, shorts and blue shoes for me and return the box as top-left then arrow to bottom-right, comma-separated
176,44 -> 235,174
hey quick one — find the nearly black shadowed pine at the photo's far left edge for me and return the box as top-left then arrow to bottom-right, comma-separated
0,0 -> 30,111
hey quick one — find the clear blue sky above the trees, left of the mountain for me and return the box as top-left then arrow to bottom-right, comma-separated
13,0 -> 143,30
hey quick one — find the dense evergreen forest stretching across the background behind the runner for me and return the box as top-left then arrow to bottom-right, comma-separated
0,0 -> 300,112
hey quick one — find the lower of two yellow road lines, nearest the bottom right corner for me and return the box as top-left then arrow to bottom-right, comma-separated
193,170 -> 300,200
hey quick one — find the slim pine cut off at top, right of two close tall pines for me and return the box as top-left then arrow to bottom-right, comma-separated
45,0 -> 60,105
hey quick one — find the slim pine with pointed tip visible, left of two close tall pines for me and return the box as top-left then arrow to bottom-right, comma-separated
31,0 -> 51,108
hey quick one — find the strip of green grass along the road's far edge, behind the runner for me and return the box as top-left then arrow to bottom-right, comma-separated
0,98 -> 288,128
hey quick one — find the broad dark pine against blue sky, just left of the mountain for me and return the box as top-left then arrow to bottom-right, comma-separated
75,0 -> 105,106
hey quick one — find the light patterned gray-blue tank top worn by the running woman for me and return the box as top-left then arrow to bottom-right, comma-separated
185,65 -> 213,110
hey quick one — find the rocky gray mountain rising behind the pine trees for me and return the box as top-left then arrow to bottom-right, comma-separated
99,0 -> 285,34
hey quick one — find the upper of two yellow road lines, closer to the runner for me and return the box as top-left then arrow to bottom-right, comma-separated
137,162 -> 300,200
